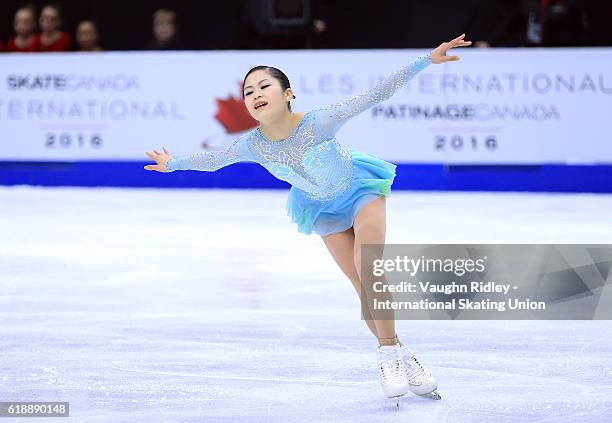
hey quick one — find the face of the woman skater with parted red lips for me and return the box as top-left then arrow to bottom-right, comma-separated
243,70 -> 293,122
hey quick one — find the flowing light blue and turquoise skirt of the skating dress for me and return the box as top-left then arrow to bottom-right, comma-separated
287,147 -> 397,236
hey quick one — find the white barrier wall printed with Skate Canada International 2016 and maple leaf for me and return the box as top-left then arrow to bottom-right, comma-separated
0,48 -> 612,164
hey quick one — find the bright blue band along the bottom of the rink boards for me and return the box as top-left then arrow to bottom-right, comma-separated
0,162 -> 612,193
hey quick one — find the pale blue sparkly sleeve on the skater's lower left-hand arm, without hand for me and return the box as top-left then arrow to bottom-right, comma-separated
166,134 -> 253,172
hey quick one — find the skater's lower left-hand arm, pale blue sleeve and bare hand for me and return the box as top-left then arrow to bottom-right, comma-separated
144,134 -> 252,172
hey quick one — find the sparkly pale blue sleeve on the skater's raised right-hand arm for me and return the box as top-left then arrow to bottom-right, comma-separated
315,52 -> 432,137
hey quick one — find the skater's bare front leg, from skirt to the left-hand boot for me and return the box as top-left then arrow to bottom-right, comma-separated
353,196 -> 396,345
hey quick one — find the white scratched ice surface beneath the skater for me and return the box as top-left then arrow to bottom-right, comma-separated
0,186 -> 612,423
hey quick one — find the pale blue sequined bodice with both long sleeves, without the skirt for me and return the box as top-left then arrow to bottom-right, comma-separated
167,53 -> 431,201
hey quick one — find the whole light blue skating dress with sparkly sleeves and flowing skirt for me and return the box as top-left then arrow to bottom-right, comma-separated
167,53 -> 432,236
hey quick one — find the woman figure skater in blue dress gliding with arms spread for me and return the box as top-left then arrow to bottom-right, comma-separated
144,34 -> 471,406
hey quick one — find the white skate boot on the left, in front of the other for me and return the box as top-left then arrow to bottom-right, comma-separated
377,344 -> 408,407
